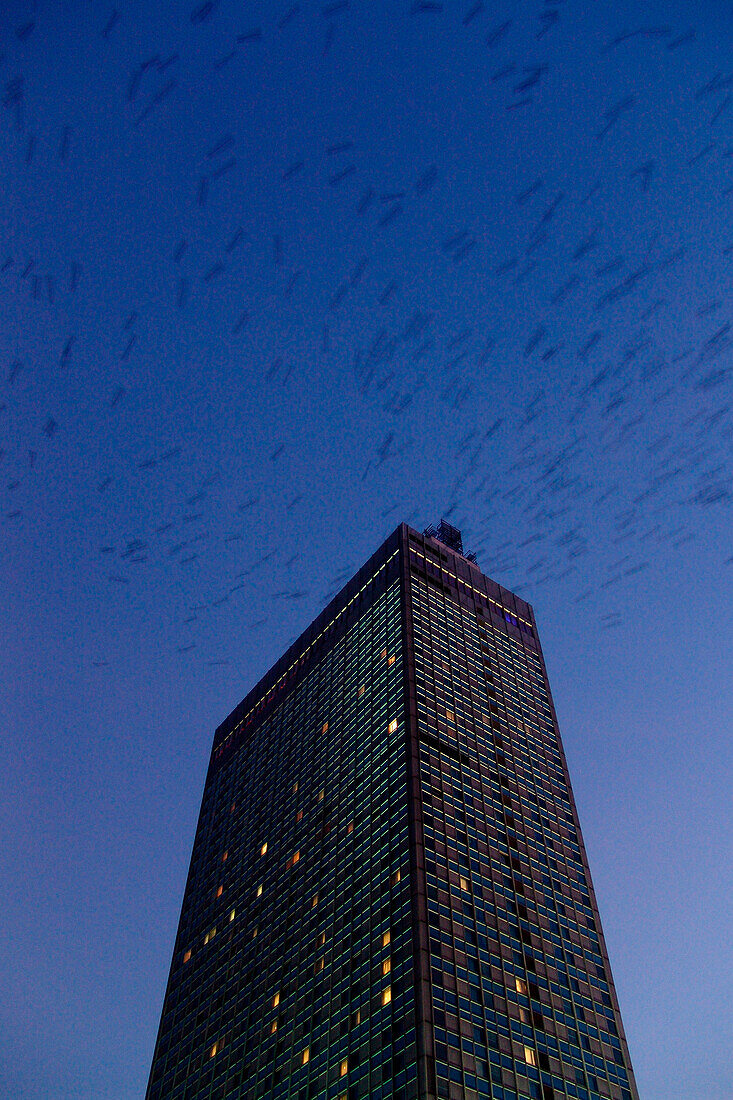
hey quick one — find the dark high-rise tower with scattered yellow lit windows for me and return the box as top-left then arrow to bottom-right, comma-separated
147,521 -> 637,1100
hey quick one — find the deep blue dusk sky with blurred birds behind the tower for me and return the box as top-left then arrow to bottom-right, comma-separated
0,0 -> 733,1100
